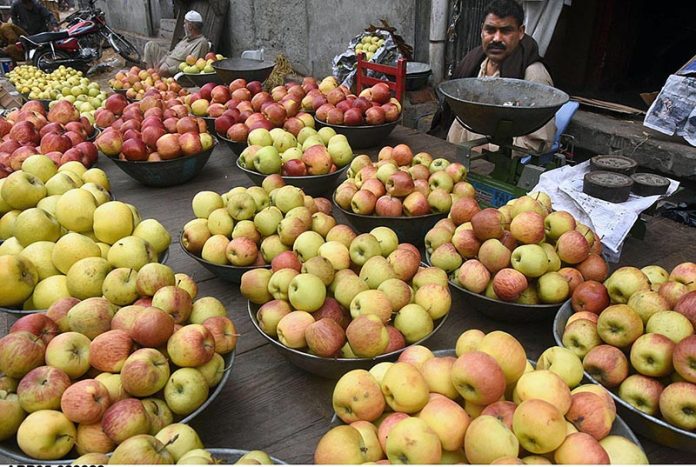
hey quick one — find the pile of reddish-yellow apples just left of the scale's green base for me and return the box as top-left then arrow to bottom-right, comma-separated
338,146 -> 468,217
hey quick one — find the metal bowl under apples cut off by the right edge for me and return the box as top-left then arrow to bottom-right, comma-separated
553,302 -> 696,453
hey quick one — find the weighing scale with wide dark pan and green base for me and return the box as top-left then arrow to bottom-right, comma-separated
439,78 -> 570,207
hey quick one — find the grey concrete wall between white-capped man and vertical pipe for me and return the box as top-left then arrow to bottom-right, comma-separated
220,0 -> 418,77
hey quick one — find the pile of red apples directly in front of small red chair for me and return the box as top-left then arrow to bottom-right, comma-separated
315,83 -> 401,126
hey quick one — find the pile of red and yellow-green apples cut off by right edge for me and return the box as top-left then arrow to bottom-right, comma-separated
562,262 -> 696,431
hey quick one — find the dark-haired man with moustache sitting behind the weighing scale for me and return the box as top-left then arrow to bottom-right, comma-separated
447,0 -> 556,153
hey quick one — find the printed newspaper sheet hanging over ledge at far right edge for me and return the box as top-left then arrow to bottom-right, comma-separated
643,75 -> 696,146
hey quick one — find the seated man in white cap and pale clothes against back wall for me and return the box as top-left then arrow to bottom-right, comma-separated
143,10 -> 210,76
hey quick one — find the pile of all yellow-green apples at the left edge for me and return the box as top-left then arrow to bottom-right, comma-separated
0,163 -> 171,310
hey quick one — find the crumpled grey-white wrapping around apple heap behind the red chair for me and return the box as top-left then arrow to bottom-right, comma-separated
331,29 -> 400,88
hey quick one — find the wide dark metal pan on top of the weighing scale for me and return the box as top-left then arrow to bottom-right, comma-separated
438,78 -> 570,138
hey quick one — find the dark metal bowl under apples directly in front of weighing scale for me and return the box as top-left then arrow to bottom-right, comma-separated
425,252 -> 570,323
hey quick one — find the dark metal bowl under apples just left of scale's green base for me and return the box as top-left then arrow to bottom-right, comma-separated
332,196 -> 447,246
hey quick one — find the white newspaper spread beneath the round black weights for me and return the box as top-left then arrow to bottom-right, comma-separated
531,161 -> 679,263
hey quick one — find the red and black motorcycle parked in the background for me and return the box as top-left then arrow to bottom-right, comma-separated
17,0 -> 140,72
